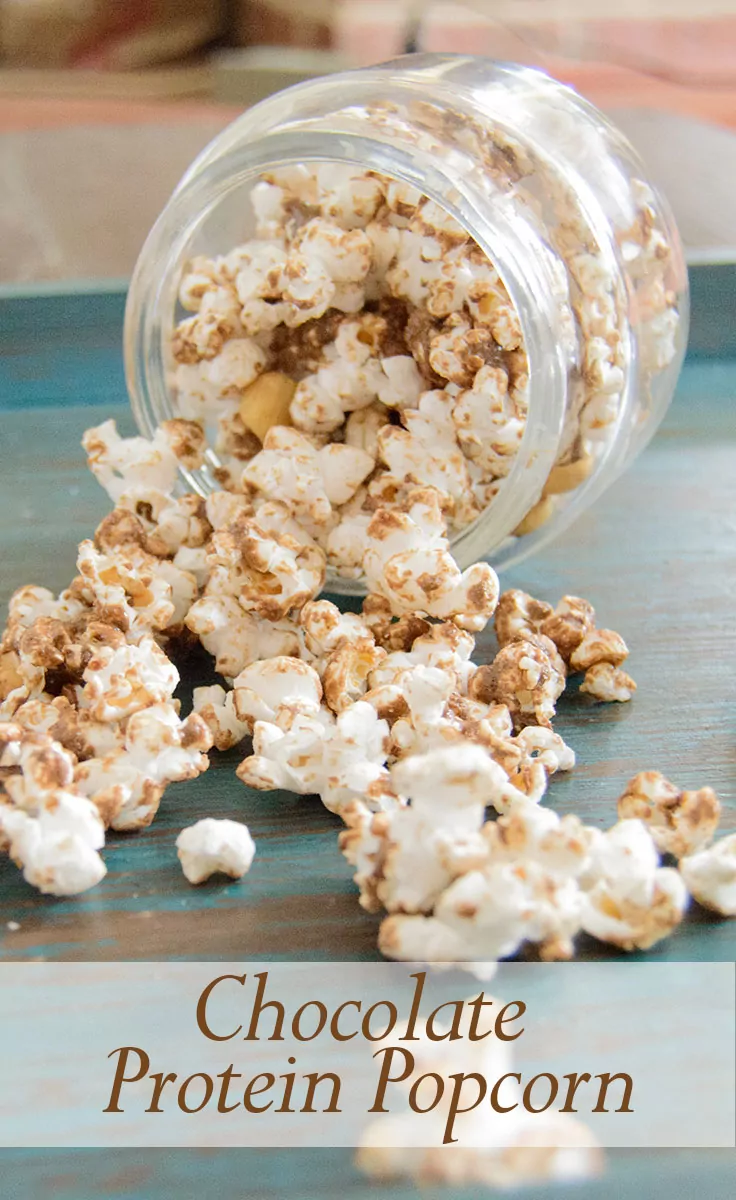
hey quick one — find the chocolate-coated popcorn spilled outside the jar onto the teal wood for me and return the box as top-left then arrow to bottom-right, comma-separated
0,418 -> 736,964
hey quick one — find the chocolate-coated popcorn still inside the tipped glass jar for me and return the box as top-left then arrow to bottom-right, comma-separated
169,160 -> 678,585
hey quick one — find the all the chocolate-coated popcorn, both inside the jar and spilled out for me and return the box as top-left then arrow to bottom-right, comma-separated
0,152 -> 686,936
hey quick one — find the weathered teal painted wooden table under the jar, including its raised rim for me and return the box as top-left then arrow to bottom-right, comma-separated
0,278 -> 736,1200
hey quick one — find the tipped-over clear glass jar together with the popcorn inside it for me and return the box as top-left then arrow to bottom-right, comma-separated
126,55 -> 688,592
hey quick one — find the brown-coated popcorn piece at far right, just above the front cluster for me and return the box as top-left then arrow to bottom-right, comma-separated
617,770 -> 720,858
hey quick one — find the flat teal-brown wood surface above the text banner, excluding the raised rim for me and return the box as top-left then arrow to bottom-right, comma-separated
0,361 -> 736,960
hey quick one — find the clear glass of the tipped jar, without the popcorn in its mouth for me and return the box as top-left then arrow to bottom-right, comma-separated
125,54 -> 688,592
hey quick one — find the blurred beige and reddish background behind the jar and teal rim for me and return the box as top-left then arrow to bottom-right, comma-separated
0,0 -> 736,286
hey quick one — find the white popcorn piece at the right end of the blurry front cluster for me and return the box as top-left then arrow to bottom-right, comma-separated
582,818 -> 688,950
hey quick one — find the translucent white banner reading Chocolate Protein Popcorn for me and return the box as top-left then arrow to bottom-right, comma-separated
0,960 -> 736,1147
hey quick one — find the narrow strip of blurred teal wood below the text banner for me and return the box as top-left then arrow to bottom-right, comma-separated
0,1150 -> 736,1200
